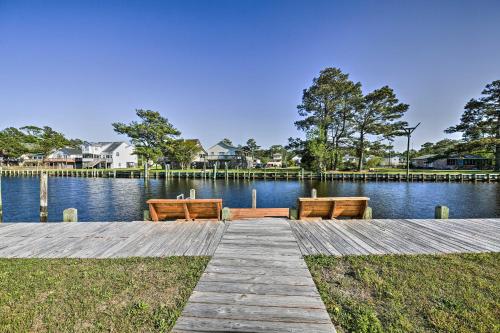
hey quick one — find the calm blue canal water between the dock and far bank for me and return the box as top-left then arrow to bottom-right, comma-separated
2,177 -> 500,222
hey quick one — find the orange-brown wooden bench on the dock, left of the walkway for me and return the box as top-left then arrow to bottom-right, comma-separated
147,199 -> 222,222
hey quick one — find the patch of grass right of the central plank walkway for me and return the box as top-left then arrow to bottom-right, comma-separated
306,253 -> 500,333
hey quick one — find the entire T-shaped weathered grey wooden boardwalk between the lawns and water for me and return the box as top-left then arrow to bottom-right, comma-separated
0,219 -> 500,332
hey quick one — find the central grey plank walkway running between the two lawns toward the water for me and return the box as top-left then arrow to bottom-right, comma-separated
173,219 -> 335,332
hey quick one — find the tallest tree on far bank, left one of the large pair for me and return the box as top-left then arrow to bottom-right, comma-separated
295,68 -> 362,170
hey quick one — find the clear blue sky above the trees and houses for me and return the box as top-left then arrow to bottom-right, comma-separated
0,0 -> 500,148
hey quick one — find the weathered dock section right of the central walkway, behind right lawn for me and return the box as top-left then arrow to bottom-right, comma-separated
289,219 -> 500,255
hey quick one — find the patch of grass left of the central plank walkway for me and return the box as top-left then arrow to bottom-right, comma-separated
0,257 -> 208,332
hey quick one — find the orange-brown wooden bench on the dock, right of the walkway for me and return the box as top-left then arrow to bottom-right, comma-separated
297,197 -> 371,220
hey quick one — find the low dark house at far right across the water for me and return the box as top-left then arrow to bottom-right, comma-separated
410,154 -> 493,170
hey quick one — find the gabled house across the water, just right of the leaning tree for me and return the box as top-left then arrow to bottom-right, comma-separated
205,141 -> 252,168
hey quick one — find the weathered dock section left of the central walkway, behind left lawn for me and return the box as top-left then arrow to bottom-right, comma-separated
0,221 -> 227,258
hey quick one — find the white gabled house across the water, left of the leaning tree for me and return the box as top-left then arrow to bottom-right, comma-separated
82,141 -> 137,169
